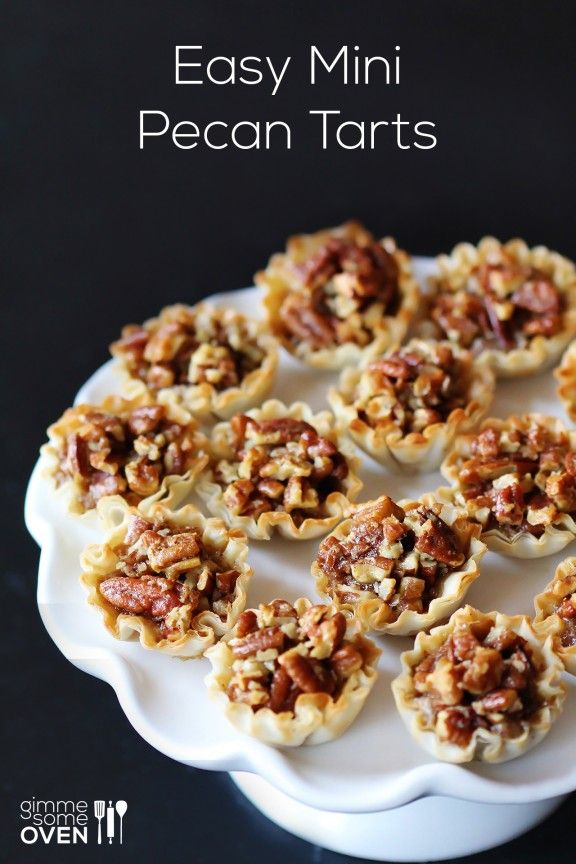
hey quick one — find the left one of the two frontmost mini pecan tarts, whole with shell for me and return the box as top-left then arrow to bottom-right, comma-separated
206,598 -> 380,747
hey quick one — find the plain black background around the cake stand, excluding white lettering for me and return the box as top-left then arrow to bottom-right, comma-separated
0,0 -> 576,864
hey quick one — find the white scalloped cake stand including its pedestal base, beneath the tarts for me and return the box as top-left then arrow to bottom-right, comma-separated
26,259 -> 576,861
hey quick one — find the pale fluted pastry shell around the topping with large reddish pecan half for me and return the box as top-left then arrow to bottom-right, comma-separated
80,496 -> 252,658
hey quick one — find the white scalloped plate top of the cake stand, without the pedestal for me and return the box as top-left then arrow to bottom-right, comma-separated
26,259 -> 576,813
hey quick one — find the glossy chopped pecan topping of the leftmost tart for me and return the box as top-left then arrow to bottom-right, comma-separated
55,405 -> 197,510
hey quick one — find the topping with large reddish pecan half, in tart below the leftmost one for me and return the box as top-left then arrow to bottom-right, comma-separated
98,515 -> 238,637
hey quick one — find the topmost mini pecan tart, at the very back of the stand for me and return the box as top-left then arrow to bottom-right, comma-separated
254,222 -> 420,369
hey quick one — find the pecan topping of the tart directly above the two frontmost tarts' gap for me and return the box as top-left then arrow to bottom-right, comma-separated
316,496 -> 469,621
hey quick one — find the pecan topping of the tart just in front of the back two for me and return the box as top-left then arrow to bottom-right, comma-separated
353,341 -> 472,435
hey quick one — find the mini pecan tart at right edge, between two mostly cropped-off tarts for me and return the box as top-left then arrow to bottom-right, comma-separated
436,414 -> 576,558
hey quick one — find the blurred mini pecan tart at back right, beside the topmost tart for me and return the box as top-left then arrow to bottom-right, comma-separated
422,237 -> 576,376
